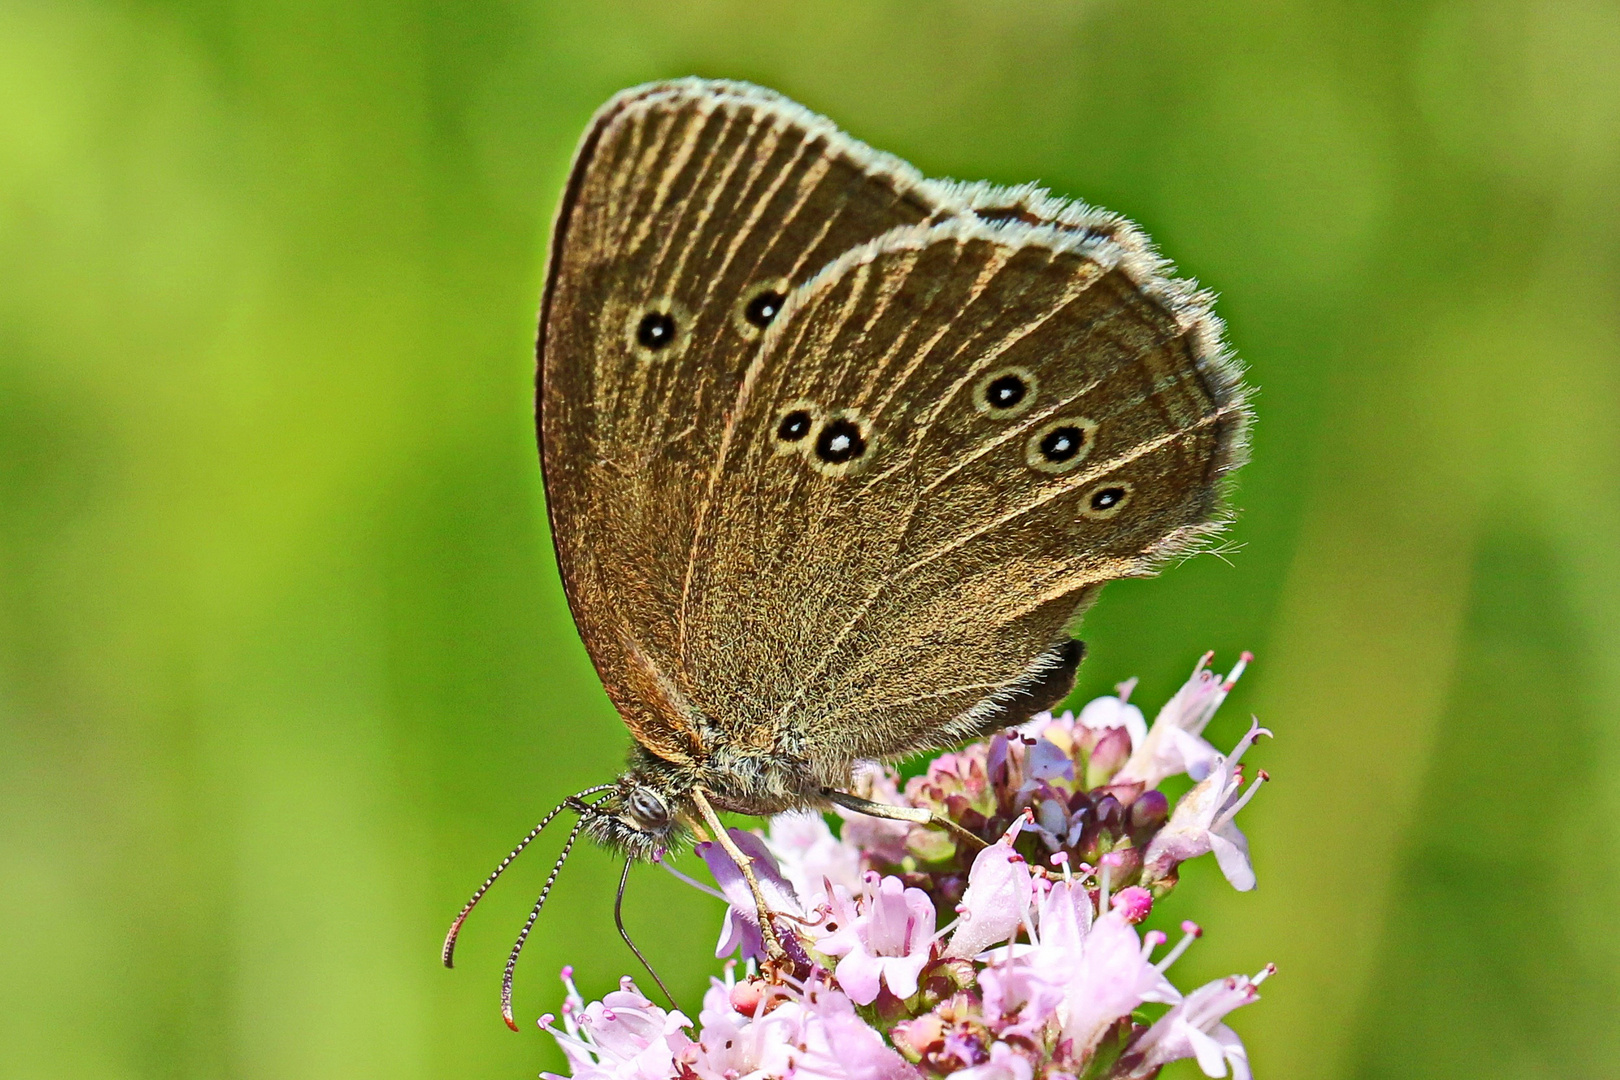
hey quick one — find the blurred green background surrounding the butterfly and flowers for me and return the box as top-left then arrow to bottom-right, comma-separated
0,0 -> 1620,1080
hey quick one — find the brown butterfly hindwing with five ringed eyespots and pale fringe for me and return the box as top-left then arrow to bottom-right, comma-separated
677,217 -> 1246,761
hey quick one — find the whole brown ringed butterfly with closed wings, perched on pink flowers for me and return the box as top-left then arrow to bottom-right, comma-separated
444,79 -> 1247,1023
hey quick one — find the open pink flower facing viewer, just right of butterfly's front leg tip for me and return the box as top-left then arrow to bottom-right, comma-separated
818,871 -> 935,1006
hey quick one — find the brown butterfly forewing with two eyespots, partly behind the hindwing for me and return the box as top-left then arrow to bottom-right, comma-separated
536,79 -> 940,761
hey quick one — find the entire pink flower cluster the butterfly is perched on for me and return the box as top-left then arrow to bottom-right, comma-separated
541,654 -> 1272,1080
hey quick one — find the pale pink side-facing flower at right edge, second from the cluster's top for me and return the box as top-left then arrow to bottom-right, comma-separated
1142,722 -> 1270,892
